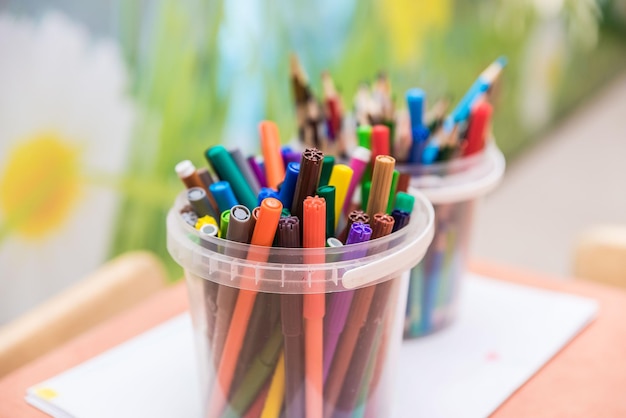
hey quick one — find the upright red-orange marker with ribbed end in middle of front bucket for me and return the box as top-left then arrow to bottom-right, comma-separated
302,196 -> 326,418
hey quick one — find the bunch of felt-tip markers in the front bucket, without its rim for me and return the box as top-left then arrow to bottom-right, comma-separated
176,121 -> 424,418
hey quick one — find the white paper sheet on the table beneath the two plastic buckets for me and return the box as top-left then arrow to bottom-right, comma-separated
26,275 -> 597,418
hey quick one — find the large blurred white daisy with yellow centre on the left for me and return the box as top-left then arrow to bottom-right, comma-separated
0,13 -> 135,323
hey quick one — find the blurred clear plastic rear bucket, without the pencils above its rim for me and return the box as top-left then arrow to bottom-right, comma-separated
398,143 -> 505,338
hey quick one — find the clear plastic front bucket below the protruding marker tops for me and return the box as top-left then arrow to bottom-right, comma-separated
167,192 -> 434,418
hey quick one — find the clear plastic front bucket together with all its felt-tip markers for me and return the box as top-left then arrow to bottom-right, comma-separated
168,118 -> 432,418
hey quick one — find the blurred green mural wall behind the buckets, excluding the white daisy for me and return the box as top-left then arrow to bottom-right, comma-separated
0,0 -> 626,294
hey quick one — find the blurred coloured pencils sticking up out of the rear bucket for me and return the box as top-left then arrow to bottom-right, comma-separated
291,56 -> 506,165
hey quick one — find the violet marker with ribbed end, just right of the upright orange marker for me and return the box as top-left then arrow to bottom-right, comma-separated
324,222 -> 372,382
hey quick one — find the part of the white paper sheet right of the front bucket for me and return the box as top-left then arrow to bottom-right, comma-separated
395,275 -> 598,418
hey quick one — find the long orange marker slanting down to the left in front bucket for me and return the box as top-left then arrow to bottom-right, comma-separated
209,197 -> 282,417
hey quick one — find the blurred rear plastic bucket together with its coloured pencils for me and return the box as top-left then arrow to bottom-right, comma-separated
291,57 -> 506,337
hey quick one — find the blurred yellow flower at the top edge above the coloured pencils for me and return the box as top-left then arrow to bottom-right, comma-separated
376,0 -> 451,65
